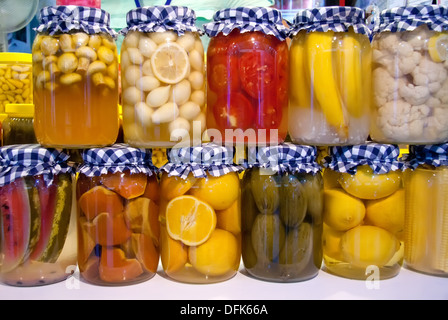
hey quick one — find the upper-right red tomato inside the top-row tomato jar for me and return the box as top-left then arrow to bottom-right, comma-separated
239,51 -> 275,99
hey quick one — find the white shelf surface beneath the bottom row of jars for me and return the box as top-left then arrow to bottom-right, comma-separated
0,266 -> 448,300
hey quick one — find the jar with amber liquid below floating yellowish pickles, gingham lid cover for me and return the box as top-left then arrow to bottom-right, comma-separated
32,6 -> 119,148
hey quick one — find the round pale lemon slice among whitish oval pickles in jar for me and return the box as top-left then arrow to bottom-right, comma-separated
151,42 -> 190,84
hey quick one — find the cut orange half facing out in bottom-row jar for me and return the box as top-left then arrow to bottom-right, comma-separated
165,196 -> 216,246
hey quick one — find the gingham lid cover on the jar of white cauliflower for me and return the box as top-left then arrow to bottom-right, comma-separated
374,5 -> 448,33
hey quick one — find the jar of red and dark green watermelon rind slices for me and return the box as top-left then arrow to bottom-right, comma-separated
0,144 -> 77,286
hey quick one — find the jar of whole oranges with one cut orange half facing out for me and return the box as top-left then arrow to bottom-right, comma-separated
159,143 -> 241,283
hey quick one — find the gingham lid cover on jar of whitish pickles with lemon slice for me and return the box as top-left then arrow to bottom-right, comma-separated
120,6 -> 203,36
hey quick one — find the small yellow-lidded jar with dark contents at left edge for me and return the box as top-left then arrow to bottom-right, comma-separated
2,104 -> 37,146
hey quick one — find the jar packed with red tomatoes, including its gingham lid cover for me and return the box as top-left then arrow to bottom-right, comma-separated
204,7 -> 289,144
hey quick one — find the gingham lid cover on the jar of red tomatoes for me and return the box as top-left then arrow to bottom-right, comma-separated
203,7 -> 289,41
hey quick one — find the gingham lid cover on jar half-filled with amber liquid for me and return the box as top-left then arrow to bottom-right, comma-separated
36,6 -> 117,38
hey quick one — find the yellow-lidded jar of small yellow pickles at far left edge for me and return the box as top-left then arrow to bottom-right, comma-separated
0,52 -> 33,112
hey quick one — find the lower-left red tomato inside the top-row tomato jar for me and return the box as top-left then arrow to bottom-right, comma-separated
212,92 -> 255,130
